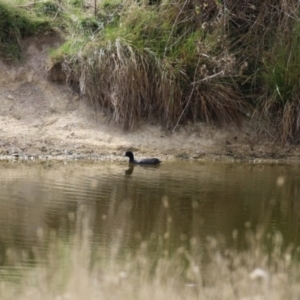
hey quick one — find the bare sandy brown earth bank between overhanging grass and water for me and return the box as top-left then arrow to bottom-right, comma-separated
0,36 -> 300,163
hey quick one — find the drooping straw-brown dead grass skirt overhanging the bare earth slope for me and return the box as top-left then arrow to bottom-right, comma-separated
62,38 -> 175,129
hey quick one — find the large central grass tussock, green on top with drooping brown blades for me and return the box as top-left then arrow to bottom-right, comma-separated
48,1 -> 249,129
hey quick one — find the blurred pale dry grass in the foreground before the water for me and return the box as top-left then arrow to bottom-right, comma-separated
0,209 -> 300,300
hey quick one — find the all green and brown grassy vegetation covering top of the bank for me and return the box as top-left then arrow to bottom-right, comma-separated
0,0 -> 300,143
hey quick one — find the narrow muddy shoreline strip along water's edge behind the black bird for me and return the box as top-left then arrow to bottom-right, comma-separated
0,140 -> 300,165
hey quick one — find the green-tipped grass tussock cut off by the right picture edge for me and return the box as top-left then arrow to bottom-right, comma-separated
260,20 -> 300,143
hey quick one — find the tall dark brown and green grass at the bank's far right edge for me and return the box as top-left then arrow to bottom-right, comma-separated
227,0 -> 300,144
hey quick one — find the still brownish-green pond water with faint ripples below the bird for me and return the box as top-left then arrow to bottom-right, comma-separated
0,162 -> 300,266
